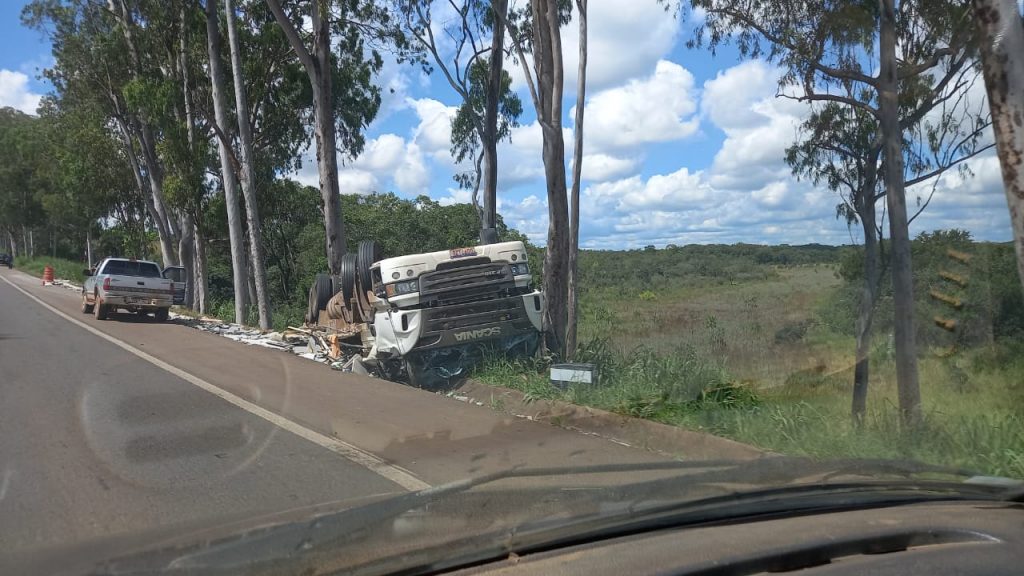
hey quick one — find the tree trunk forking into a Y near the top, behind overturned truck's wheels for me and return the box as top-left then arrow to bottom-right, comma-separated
266,0 -> 345,275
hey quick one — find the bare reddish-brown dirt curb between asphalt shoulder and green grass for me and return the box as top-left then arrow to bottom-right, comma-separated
449,380 -> 770,460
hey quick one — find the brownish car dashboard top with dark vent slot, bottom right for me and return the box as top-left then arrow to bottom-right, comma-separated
455,501 -> 1024,576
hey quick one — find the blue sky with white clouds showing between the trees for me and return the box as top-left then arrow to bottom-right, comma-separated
0,0 -> 1010,248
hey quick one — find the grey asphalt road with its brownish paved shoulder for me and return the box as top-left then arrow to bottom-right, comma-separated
0,269 -> 657,573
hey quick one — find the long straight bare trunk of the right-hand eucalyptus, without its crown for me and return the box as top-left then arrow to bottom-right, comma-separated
879,0 -> 922,427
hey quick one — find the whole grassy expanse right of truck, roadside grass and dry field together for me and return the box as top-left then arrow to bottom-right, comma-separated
474,265 -> 1024,478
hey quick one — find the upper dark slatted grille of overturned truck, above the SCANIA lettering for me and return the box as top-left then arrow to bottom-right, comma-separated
420,262 -> 515,305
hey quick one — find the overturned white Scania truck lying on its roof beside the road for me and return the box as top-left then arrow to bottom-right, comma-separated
306,241 -> 545,387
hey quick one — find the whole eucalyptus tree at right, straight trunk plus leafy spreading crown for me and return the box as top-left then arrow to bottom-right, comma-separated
689,0 -> 983,426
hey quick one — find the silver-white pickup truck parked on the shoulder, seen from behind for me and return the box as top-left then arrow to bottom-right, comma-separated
82,258 -> 174,322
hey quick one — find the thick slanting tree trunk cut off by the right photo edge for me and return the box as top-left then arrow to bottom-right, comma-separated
974,0 -> 1024,293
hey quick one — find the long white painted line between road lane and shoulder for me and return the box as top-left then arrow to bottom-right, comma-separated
0,277 -> 430,491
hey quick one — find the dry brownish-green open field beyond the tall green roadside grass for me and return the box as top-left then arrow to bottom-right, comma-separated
580,264 -> 852,388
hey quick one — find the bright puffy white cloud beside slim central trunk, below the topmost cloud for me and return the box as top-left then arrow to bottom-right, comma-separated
584,60 -> 699,151
